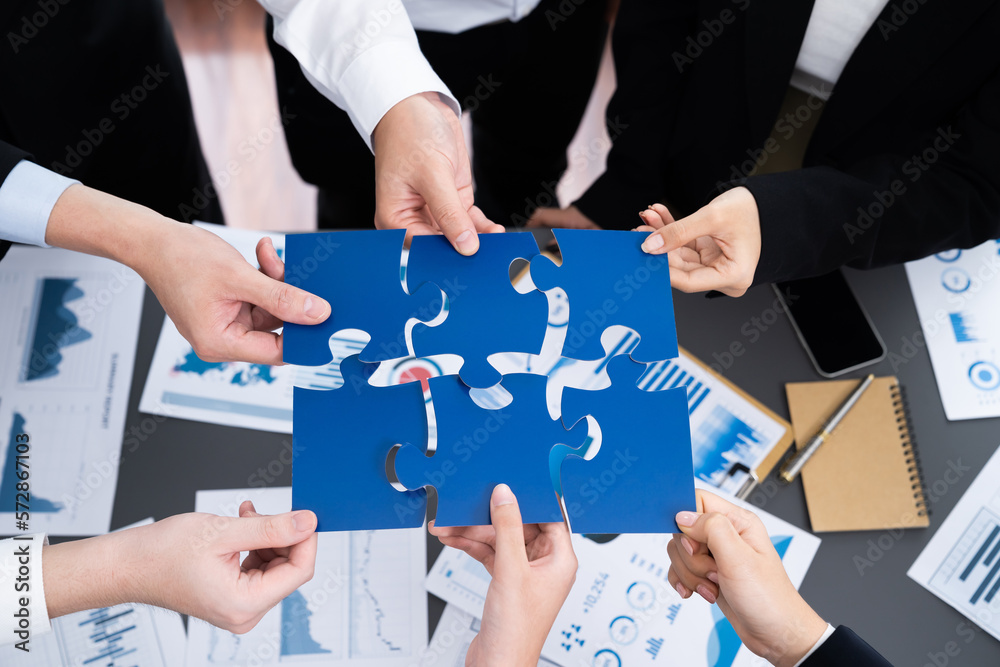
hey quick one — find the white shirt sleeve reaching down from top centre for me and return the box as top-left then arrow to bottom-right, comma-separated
259,0 -> 461,148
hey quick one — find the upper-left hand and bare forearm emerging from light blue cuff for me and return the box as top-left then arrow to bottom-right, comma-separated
45,185 -> 330,365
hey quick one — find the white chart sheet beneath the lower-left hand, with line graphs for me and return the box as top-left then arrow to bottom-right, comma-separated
187,487 -> 427,667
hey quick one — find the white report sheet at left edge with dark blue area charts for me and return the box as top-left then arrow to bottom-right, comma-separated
0,247 -> 146,535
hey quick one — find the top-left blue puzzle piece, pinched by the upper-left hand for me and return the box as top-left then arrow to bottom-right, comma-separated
284,229 -> 443,366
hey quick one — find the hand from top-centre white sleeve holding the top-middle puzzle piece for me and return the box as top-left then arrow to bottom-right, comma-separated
372,93 -> 504,255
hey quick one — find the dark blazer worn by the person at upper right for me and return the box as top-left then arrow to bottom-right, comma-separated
576,0 -> 1000,283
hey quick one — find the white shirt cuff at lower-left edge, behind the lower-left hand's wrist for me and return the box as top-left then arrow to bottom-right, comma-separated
0,533 -> 52,650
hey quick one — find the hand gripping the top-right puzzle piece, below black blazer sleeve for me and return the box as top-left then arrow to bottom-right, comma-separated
636,187 -> 760,296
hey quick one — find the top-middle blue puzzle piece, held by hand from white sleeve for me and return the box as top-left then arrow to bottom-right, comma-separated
406,232 -> 549,388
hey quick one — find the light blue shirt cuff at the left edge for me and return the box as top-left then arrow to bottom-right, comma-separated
0,160 -> 80,248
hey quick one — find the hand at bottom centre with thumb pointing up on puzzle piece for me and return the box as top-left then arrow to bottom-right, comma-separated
430,484 -> 577,667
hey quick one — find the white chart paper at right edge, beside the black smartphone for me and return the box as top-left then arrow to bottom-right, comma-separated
904,241 -> 1000,421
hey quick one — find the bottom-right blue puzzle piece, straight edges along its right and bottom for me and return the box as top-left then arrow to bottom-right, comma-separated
561,355 -> 695,534
